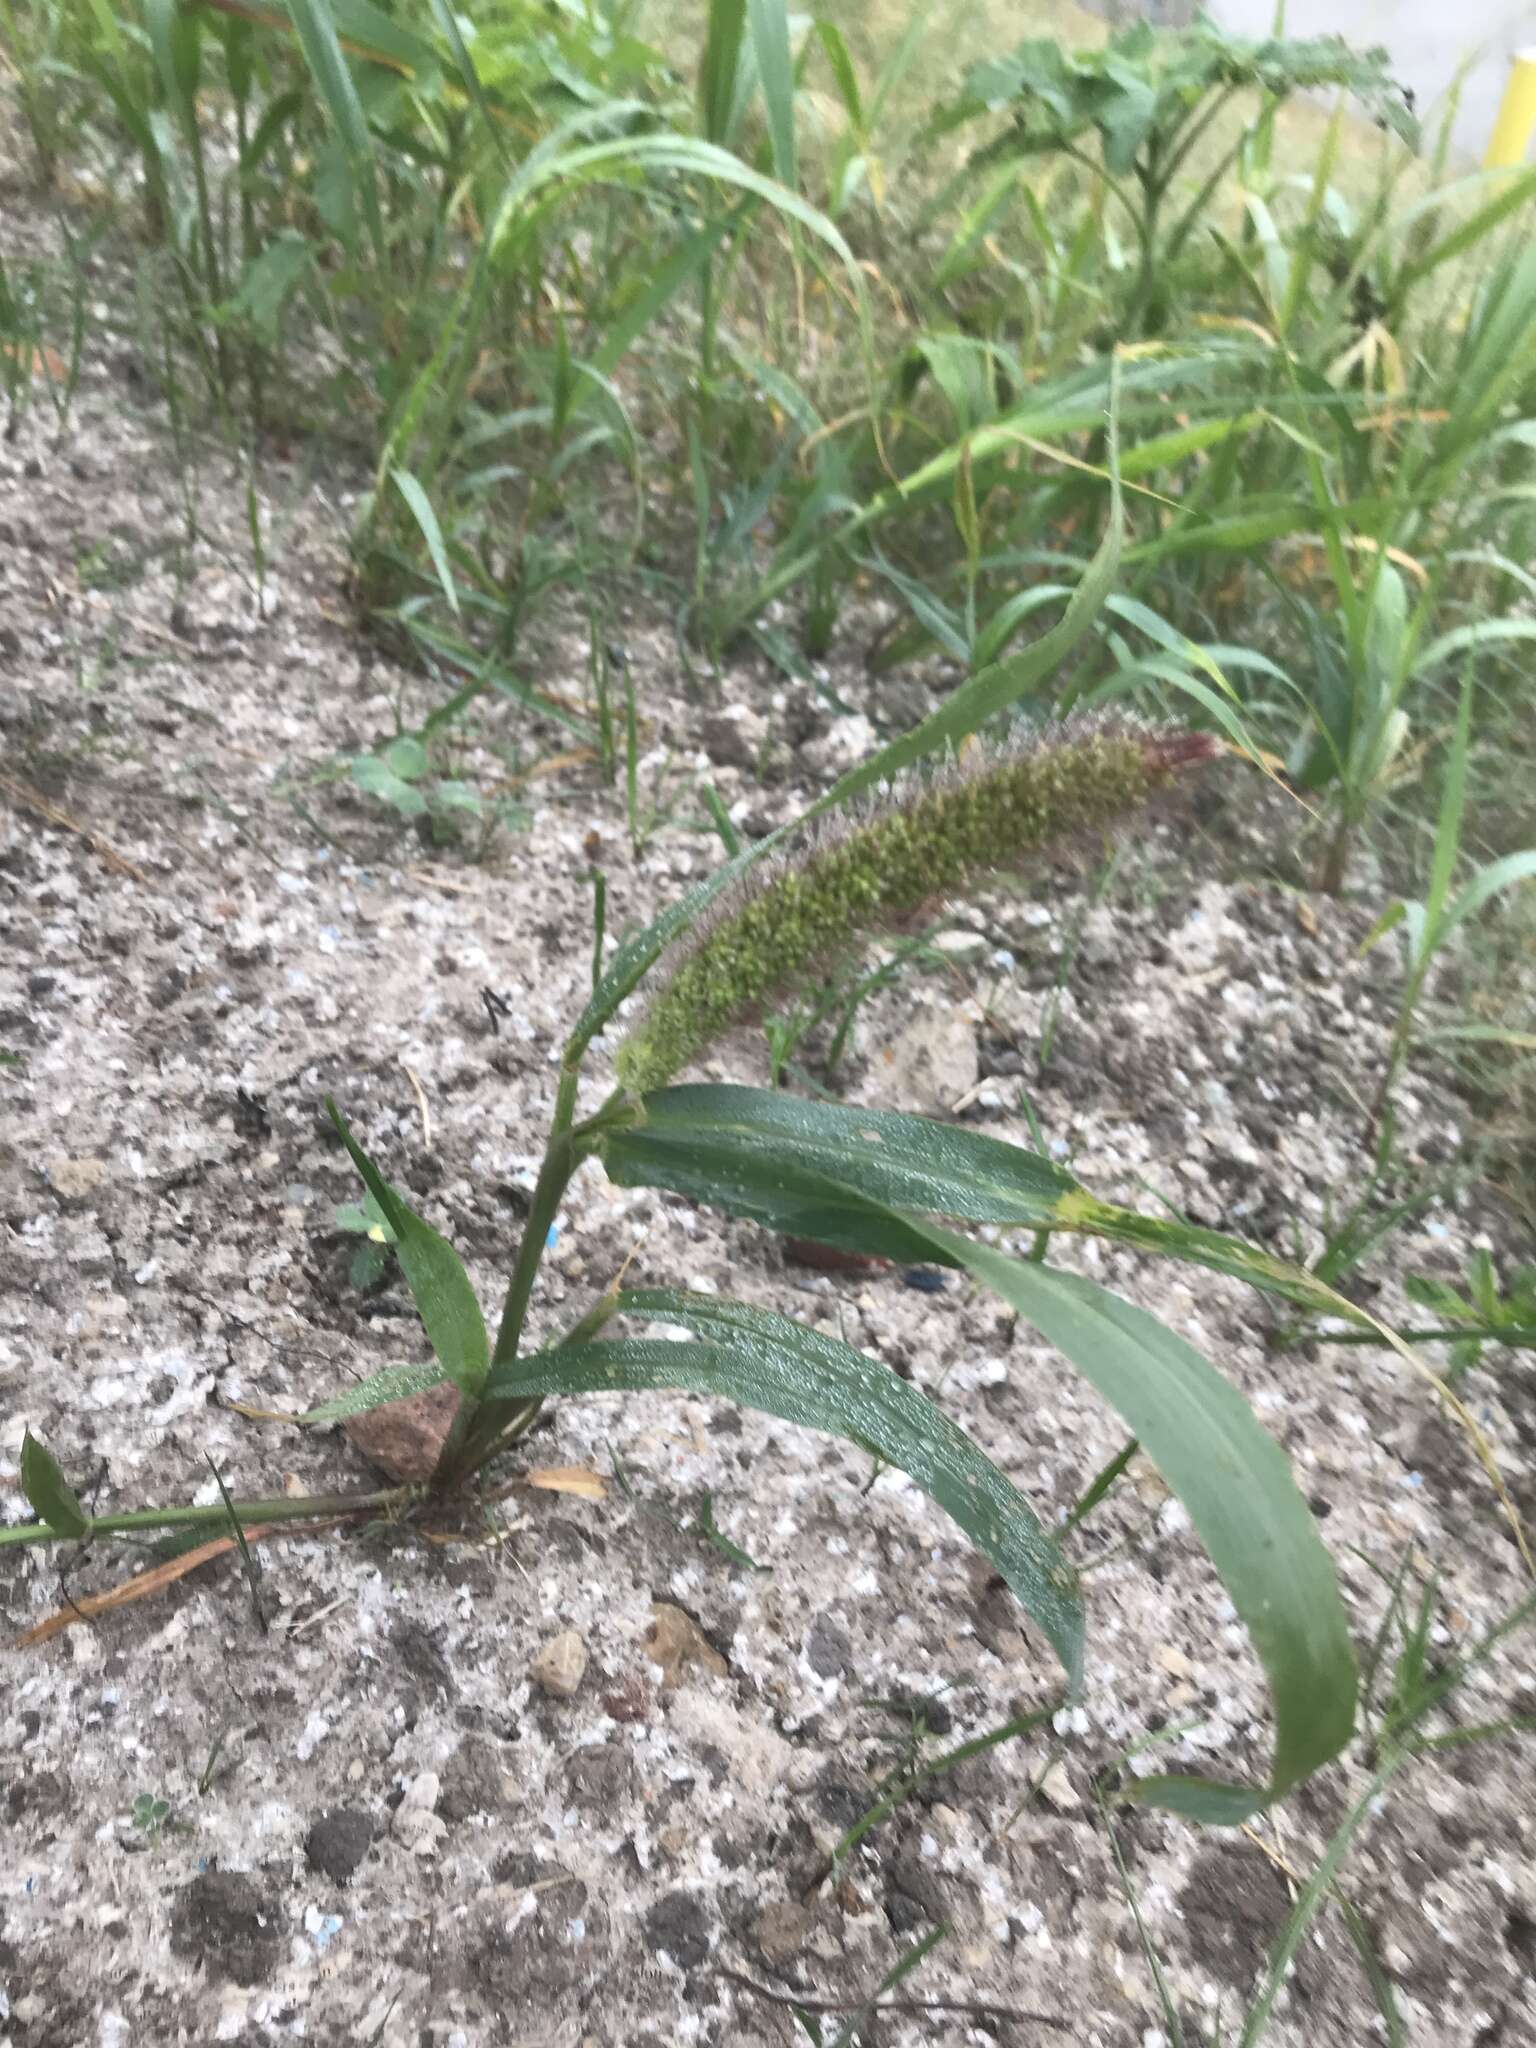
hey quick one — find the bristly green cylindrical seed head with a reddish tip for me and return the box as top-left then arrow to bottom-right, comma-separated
616,721 -> 1219,1096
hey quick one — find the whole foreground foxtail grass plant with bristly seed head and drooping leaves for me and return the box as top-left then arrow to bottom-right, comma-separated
12,593 -> 1417,1823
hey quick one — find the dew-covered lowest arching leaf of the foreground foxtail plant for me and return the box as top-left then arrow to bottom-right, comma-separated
485,1288 -> 1083,1683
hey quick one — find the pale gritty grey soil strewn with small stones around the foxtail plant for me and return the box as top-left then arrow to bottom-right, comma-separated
0,180 -> 1536,2048
